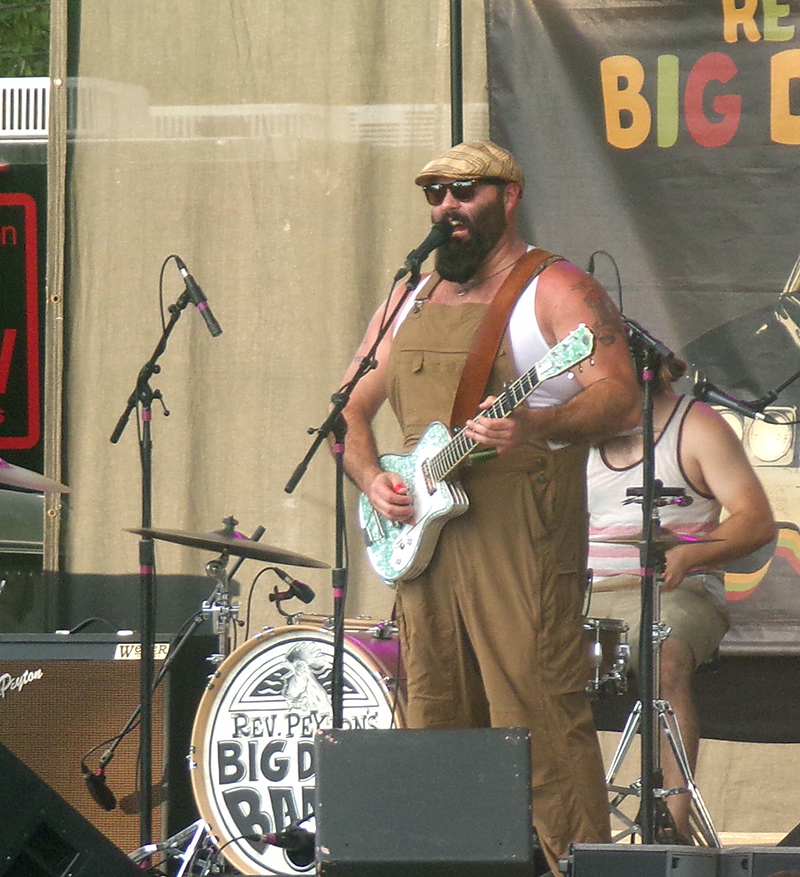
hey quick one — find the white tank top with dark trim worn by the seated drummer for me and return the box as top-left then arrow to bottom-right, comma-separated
587,396 -> 724,599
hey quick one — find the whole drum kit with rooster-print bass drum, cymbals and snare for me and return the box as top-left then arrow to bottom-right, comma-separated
0,452 -> 713,877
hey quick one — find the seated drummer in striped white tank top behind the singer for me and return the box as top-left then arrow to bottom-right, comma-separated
588,337 -> 775,842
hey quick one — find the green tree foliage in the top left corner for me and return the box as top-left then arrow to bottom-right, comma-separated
0,0 -> 50,76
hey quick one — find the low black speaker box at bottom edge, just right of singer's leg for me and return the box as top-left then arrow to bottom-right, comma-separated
561,844 -> 719,877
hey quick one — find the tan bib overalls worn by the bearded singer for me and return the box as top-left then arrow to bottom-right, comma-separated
388,292 -> 610,873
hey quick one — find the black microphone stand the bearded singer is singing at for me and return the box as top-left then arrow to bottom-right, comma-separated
284,262 -> 420,729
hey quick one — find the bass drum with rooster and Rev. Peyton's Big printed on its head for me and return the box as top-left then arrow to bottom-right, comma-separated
189,615 -> 405,874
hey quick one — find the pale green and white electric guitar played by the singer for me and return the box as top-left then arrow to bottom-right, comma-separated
359,323 -> 594,585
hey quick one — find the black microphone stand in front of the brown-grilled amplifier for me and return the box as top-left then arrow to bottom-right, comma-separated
111,290 -> 190,846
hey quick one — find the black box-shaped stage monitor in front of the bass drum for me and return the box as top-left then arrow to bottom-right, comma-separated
315,728 -> 536,877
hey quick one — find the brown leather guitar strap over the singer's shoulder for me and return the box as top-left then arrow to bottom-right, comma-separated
450,249 -> 564,429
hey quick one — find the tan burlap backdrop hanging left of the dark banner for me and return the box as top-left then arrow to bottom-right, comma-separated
54,0 -> 488,625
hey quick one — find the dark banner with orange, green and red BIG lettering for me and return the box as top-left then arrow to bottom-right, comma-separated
485,0 -> 800,642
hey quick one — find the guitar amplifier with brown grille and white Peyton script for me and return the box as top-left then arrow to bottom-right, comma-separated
0,634 -> 216,852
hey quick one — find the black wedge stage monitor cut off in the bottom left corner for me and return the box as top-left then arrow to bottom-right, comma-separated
0,744 -> 146,877
